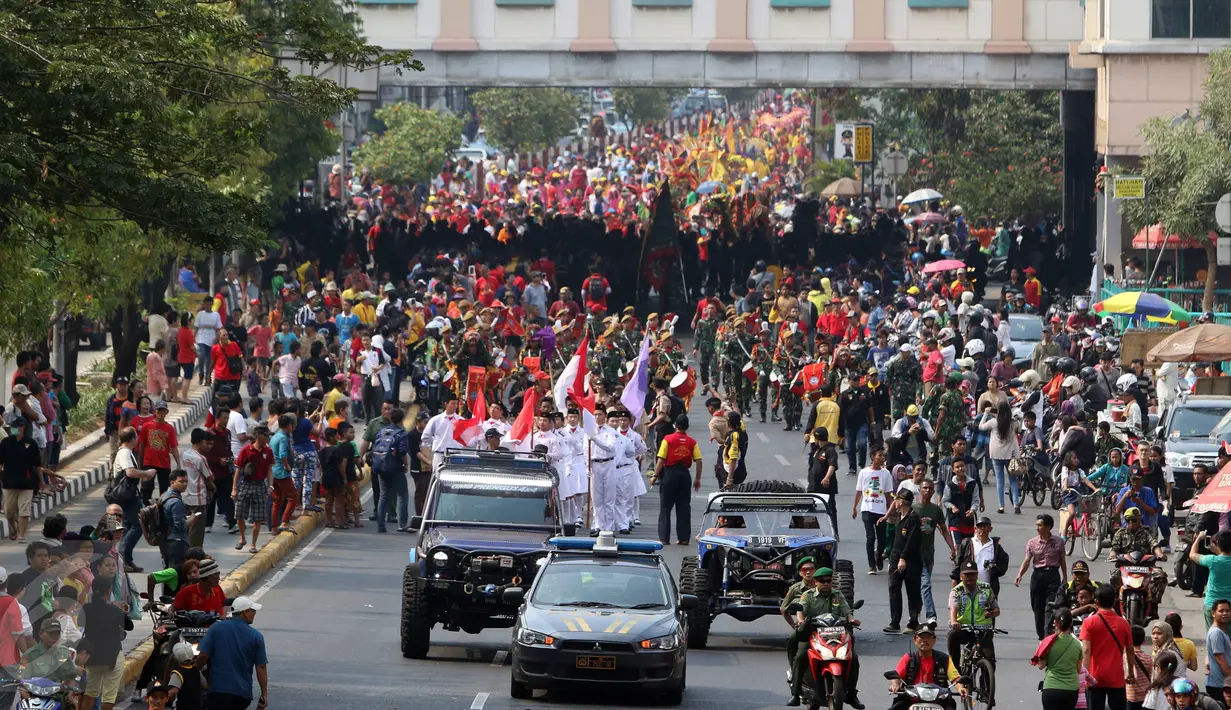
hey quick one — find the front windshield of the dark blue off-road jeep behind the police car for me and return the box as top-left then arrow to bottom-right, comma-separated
435,482 -> 553,525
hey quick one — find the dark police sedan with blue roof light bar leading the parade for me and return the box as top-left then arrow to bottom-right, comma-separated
503,532 -> 697,705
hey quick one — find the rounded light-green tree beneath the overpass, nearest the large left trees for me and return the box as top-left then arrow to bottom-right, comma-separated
355,102 -> 462,182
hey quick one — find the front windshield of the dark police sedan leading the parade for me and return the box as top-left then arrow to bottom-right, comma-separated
531,564 -> 667,609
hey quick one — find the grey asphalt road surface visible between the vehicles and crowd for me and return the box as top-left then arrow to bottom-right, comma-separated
226,388 -> 1200,710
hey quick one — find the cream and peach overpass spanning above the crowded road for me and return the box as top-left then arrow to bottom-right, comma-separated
334,0 -> 1096,94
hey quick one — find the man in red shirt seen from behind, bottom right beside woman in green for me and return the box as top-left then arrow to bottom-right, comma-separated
1081,584 -> 1136,710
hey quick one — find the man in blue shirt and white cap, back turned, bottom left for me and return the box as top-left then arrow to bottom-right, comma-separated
197,597 -> 270,710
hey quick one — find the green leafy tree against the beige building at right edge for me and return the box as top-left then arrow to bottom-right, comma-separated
1120,49 -> 1231,310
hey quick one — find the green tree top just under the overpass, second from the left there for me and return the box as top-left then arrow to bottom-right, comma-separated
470,87 -> 579,153
